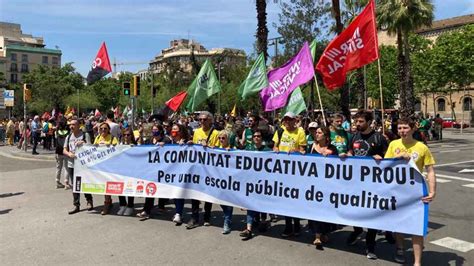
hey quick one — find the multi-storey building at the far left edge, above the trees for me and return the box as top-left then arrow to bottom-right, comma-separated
0,22 -> 62,84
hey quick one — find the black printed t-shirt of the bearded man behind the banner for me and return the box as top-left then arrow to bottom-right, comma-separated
349,130 -> 388,157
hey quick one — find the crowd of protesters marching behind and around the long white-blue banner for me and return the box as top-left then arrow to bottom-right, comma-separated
2,108 -> 436,264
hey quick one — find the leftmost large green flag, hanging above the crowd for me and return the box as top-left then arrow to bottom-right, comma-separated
186,59 -> 221,112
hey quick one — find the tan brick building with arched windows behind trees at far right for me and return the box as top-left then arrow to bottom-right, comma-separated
378,14 -> 474,125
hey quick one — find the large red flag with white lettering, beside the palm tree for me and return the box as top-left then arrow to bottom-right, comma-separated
316,0 -> 379,90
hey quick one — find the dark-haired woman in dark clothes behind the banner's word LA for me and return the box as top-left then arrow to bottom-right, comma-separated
137,124 -> 171,219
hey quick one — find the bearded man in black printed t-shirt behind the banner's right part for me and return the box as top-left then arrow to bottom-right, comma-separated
347,111 -> 395,260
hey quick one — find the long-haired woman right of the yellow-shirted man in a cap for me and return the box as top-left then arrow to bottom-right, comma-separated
308,126 -> 337,250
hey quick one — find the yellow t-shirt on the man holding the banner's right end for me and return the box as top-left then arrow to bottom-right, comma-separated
385,139 -> 435,172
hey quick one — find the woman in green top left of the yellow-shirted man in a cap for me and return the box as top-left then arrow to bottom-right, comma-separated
240,129 -> 271,240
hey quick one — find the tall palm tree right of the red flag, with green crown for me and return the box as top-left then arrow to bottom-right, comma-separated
377,0 -> 434,117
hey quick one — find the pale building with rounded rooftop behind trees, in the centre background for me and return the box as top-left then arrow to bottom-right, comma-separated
150,39 -> 246,74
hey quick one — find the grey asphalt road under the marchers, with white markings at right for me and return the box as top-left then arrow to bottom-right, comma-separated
0,132 -> 474,265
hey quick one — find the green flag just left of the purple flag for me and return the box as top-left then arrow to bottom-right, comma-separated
239,53 -> 268,100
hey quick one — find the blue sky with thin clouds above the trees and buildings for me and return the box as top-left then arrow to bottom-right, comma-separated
0,0 -> 474,76
